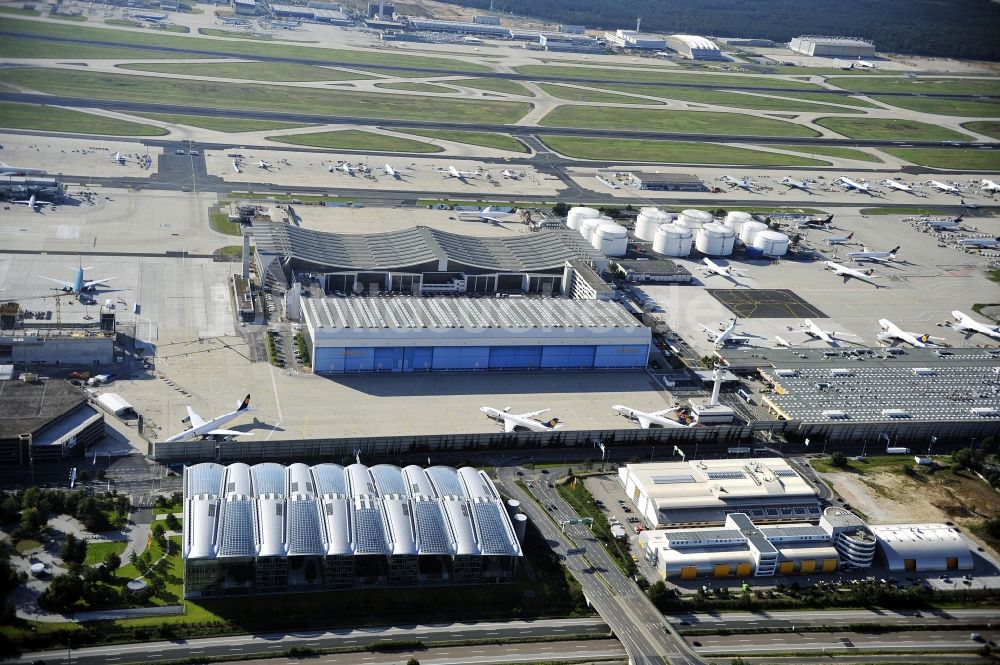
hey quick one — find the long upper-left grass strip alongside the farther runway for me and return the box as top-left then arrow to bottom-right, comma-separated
0,17 -> 490,73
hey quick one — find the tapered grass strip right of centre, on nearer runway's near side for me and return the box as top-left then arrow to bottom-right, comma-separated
538,134 -> 830,166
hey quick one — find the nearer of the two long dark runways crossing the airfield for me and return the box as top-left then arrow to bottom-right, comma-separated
0,91 -> 1000,150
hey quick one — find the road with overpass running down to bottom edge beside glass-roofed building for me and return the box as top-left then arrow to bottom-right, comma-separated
497,466 -> 703,665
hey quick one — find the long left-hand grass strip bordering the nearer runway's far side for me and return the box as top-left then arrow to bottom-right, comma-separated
0,68 -> 531,124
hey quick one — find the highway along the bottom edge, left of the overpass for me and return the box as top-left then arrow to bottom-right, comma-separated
14,618 -> 608,665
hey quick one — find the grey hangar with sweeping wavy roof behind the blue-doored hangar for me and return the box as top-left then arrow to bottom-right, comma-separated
253,221 -> 607,295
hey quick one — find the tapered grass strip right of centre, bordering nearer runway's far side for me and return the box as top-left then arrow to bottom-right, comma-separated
539,106 -> 817,136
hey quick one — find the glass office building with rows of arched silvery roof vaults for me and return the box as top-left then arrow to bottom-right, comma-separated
182,463 -> 525,598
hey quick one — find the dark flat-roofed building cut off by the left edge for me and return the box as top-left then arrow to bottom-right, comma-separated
0,375 -> 104,466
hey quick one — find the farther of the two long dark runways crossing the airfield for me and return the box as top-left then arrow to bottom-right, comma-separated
0,30 -> 984,99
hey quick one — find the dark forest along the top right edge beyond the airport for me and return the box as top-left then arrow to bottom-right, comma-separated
443,0 -> 1000,60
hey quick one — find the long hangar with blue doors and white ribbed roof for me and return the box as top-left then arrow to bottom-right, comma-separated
301,293 -> 651,373
